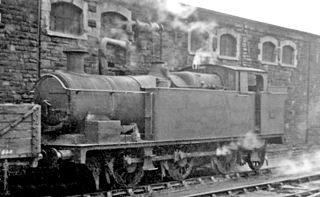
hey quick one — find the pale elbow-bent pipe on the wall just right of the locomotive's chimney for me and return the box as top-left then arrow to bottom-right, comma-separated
99,37 -> 130,75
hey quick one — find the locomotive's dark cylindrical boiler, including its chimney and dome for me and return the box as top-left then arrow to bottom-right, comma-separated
35,50 -> 222,139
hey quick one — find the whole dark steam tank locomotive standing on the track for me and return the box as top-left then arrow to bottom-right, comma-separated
4,49 -> 286,195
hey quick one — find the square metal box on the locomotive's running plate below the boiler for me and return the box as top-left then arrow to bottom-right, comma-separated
84,120 -> 122,143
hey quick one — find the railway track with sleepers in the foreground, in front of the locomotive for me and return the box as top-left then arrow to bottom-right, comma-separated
67,155 -> 320,197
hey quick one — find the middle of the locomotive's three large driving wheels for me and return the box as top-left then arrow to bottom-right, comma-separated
168,158 -> 193,181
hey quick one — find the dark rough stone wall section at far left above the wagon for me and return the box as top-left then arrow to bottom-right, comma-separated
0,0 -> 38,102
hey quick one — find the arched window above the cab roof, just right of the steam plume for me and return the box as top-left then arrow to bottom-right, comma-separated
220,34 -> 237,57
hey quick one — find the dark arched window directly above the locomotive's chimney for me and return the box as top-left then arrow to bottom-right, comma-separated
50,2 -> 82,35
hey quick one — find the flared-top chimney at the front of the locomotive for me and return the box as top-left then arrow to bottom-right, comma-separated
63,48 -> 88,74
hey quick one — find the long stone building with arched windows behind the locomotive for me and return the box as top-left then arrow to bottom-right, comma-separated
0,0 -> 320,144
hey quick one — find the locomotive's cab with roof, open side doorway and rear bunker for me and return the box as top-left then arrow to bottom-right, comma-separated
184,64 -> 287,143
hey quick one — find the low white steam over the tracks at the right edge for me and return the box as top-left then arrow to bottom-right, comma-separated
276,152 -> 320,176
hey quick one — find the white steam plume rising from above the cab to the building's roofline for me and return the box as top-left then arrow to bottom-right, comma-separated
136,0 -> 217,69
